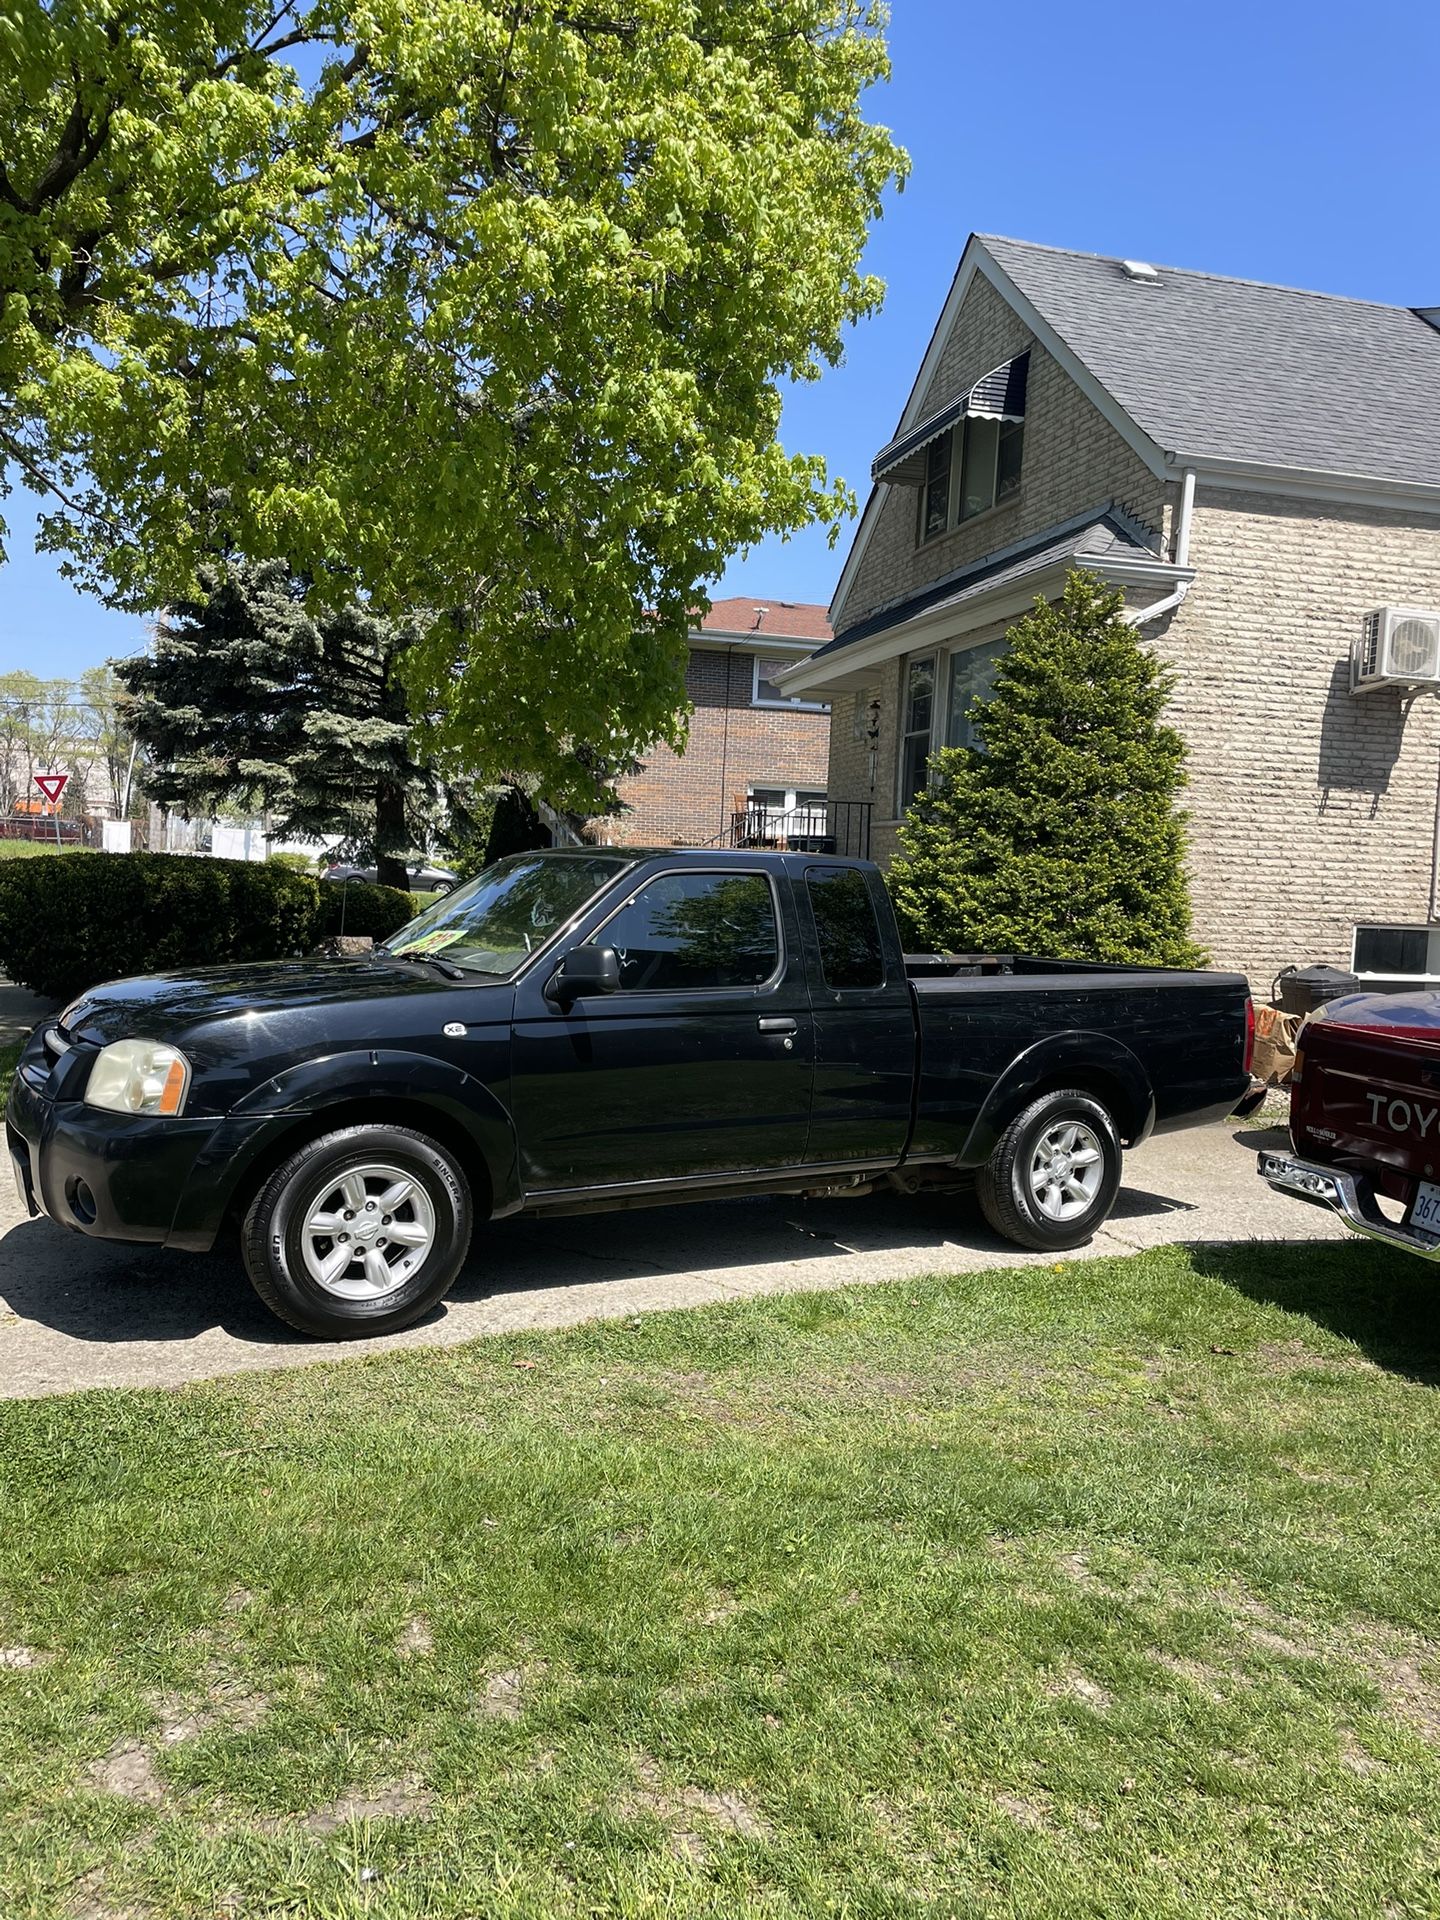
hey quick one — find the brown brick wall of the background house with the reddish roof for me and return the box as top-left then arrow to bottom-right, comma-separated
595,647 -> 829,847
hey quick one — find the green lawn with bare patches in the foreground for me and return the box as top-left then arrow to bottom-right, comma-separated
0,1244 -> 1440,1920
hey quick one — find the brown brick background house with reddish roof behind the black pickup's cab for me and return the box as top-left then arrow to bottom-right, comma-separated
593,599 -> 831,847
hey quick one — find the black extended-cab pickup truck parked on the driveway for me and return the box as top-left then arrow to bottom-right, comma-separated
6,847 -> 1250,1338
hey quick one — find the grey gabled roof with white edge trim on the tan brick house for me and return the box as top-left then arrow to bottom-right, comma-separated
829,234 -> 1440,616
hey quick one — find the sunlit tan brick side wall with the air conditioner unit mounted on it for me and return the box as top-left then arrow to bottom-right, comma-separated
1154,488 -> 1440,991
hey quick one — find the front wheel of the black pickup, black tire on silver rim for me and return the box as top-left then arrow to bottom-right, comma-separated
240,1125 -> 474,1340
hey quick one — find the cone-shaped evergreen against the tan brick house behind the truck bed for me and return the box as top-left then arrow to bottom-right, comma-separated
889,572 -> 1204,966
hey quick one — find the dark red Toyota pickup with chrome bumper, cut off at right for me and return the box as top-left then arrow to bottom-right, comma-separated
1260,993 -> 1440,1260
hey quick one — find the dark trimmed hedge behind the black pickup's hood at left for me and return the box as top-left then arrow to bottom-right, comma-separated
0,852 -> 413,1000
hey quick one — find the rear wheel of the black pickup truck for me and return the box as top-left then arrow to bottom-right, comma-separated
975,1089 -> 1121,1254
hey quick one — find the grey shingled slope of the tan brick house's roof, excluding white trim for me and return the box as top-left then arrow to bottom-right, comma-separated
975,234 -> 1440,486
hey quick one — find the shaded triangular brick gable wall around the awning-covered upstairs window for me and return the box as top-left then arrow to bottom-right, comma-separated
835,275 -> 1177,632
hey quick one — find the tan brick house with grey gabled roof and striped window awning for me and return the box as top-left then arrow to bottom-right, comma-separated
781,234 -> 1440,989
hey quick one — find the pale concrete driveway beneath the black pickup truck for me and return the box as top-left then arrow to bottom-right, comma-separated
0,1123 -> 1344,1398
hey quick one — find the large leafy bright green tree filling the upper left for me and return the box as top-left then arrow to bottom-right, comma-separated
0,0 -> 902,806
